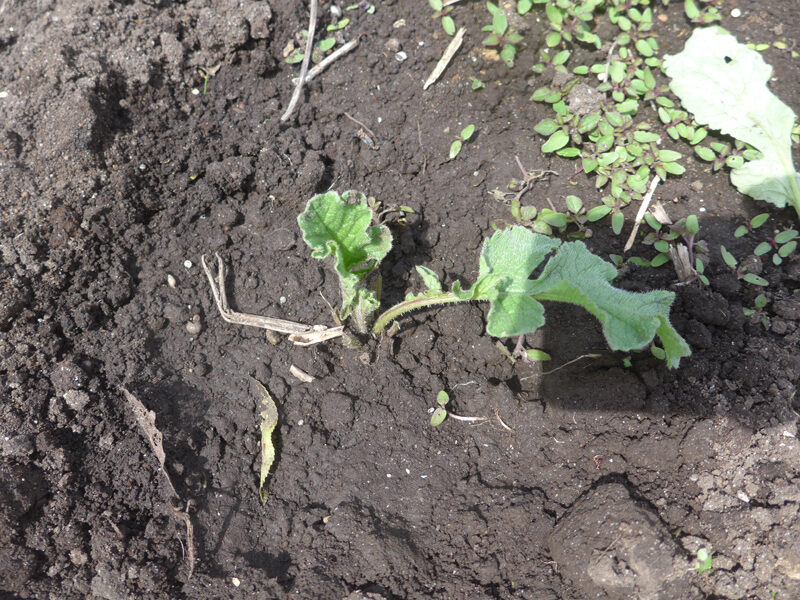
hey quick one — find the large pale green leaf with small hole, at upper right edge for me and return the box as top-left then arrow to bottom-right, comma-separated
664,27 -> 800,216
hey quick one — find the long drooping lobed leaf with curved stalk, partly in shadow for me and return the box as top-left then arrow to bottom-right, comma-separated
373,227 -> 691,368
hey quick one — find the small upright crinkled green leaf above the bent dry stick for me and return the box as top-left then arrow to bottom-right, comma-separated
297,192 -> 392,318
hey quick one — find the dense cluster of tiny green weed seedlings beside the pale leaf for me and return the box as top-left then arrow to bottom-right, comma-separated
532,0 -> 717,234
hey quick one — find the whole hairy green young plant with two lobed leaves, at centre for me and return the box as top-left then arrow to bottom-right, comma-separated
298,192 -> 691,368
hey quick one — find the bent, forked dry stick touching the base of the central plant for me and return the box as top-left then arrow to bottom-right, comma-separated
200,253 -> 344,346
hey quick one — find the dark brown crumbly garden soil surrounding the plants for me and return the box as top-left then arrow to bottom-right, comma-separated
0,0 -> 800,600
